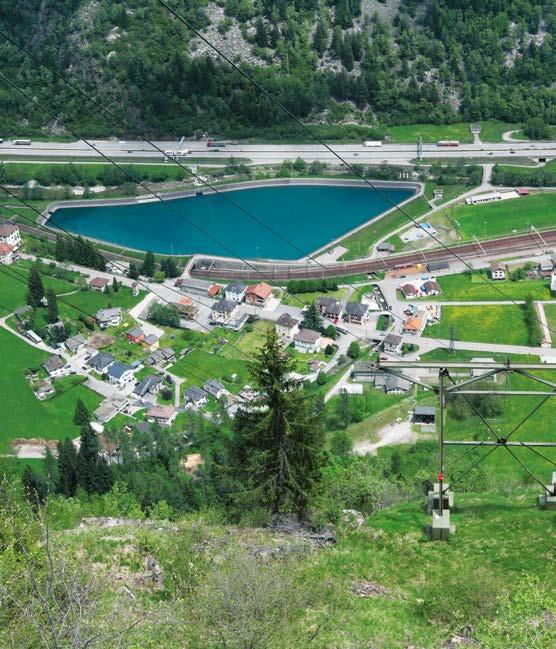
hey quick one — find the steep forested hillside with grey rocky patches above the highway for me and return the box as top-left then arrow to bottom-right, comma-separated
0,0 -> 556,137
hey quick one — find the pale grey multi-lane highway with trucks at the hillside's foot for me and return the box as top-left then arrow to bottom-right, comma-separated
0,139 -> 556,164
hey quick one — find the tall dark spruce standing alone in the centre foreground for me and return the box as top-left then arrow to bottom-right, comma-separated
231,329 -> 324,516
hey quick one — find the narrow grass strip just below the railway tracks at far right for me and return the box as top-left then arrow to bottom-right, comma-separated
427,273 -> 550,302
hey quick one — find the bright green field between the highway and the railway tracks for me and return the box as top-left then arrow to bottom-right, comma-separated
444,192 -> 556,240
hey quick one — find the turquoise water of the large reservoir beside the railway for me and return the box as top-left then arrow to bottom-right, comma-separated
50,185 -> 415,259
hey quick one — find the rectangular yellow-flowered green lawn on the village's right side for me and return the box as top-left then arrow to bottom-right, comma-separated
423,304 -> 527,345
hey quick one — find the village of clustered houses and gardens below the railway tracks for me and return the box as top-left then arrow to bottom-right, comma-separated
0,223 -> 556,466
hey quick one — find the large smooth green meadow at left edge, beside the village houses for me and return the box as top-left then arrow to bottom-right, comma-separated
0,329 -> 101,453
